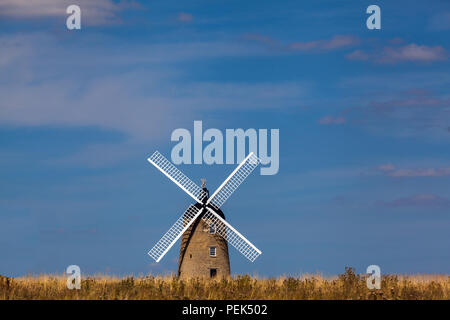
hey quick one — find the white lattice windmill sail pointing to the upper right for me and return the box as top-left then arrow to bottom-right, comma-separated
207,152 -> 260,208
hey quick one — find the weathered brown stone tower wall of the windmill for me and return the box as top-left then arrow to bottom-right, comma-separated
178,206 -> 230,278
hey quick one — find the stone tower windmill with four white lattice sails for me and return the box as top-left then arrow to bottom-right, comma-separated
147,151 -> 261,277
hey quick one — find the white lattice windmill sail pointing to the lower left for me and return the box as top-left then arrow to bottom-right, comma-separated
148,205 -> 203,262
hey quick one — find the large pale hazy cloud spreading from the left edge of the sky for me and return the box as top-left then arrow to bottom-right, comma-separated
0,34 -> 305,140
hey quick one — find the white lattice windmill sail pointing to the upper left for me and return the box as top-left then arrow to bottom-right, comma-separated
147,151 -> 205,203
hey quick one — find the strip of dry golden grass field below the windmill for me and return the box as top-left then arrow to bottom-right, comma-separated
0,268 -> 450,300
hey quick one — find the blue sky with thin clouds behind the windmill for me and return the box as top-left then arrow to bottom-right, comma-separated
0,0 -> 450,276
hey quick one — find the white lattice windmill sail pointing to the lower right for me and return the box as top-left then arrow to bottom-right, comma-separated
202,208 -> 262,262
